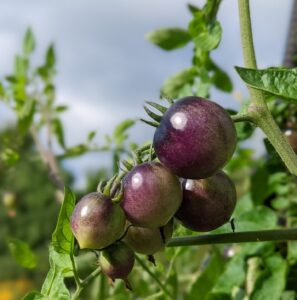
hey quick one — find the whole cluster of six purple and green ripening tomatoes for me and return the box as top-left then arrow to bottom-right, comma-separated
71,97 -> 237,287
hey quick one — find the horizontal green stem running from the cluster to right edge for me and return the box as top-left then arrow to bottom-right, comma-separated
167,228 -> 297,247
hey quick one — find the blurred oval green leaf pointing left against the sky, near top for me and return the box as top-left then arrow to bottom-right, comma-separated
146,28 -> 191,50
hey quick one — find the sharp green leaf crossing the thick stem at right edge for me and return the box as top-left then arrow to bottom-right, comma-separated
235,67 -> 297,100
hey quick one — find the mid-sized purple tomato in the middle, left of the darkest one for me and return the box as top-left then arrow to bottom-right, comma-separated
121,162 -> 182,228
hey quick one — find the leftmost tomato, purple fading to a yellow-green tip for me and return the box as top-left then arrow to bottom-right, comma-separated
71,193 -> 126,249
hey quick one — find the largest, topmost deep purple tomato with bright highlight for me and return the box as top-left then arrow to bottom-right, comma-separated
153,97 -> 237,179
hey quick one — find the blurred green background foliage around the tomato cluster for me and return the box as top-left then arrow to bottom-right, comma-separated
0,0 -> 297,300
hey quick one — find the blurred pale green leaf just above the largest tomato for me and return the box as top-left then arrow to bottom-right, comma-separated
161,68 -> 197,99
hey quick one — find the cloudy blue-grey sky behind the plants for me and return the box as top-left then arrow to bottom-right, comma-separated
0,0 -> 292,188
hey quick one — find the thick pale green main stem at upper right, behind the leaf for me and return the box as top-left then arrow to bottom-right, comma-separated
238,0 -> 297,176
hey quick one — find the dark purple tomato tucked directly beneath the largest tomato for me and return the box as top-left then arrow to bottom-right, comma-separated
176,171 -> 236,231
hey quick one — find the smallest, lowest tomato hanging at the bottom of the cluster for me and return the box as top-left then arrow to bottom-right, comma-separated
99,242 -> 135,280
